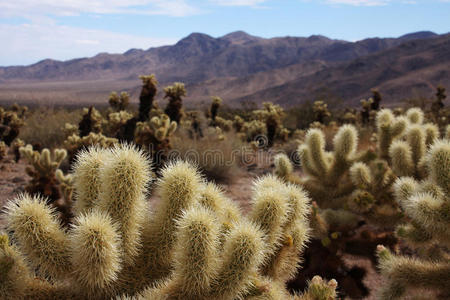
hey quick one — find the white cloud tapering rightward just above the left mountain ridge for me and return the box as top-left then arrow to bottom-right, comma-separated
0,23 -> 176,66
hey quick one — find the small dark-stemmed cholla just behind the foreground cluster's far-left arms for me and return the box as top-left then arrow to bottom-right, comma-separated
19,145 -> 67,202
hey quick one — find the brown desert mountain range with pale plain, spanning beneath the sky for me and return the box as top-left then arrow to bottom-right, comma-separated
0,31 -> 450,106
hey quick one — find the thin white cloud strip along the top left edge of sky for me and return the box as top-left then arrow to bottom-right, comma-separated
0,0 -> 200,17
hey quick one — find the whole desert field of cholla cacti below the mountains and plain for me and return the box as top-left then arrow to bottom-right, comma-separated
0,74 -> 450,300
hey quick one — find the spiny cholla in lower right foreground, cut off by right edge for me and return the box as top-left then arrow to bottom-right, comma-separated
378,140 -> 450,299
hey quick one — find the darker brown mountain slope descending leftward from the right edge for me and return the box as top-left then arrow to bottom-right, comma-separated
232,34 -> 450,105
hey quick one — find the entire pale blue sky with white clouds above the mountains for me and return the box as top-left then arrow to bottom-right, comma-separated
0,0 -> 450,66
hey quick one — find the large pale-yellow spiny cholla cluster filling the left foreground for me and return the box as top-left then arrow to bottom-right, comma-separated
0,145 -> 336,299
